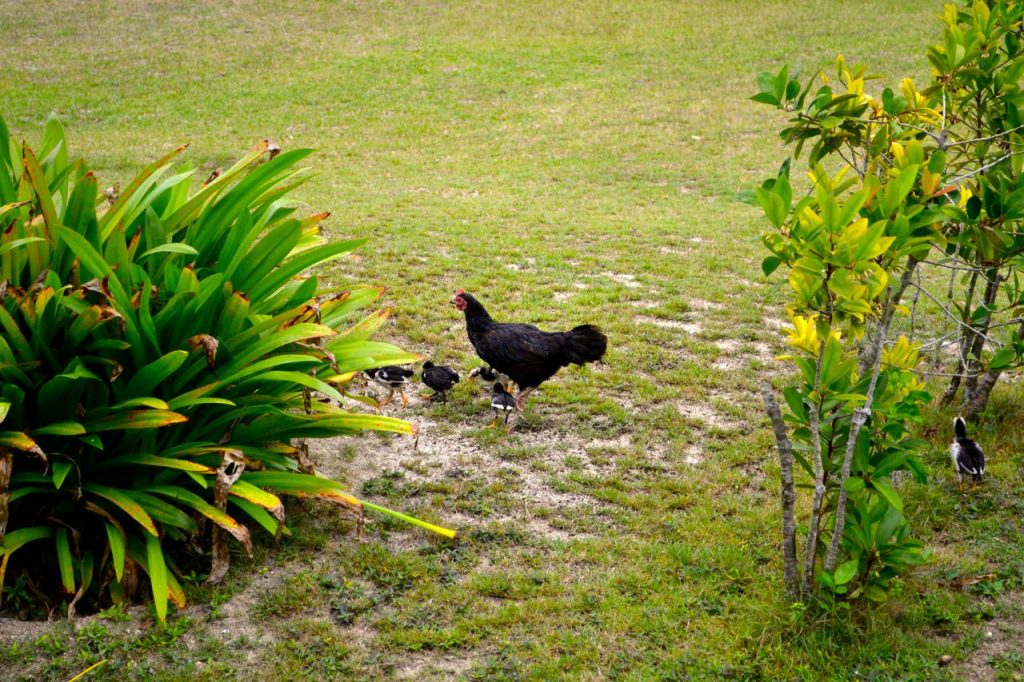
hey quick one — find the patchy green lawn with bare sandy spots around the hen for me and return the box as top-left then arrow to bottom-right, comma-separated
0,0 -> 1024,680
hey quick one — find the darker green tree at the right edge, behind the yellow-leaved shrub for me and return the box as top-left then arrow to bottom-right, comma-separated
922,2 -> 1024,416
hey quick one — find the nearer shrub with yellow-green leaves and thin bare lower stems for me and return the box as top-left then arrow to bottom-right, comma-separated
755,62 -> 942,601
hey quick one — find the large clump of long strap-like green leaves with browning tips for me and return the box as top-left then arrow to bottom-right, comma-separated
0,120 -> 452,620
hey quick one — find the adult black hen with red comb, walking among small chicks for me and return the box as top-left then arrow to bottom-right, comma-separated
452,289 -> 608,419
